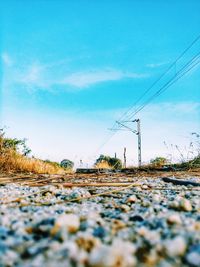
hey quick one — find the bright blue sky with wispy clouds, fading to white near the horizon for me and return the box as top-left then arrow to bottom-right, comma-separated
0,0 -> 200,168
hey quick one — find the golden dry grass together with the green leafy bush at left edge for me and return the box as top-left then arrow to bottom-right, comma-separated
0,130 -> 64,174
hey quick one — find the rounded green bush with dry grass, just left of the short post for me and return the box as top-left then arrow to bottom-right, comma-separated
95,155 -> 122,169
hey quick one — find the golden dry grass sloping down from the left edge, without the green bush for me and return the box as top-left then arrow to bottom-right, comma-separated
0,136 -> 65,174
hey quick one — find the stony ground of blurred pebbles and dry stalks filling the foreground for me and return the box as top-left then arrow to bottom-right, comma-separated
0,172 -> 200,267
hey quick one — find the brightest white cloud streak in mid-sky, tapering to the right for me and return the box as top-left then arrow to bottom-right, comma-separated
60,69 -> 147,88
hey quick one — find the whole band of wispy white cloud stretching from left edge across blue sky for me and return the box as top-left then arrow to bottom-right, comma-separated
2,52 -> 149,90
